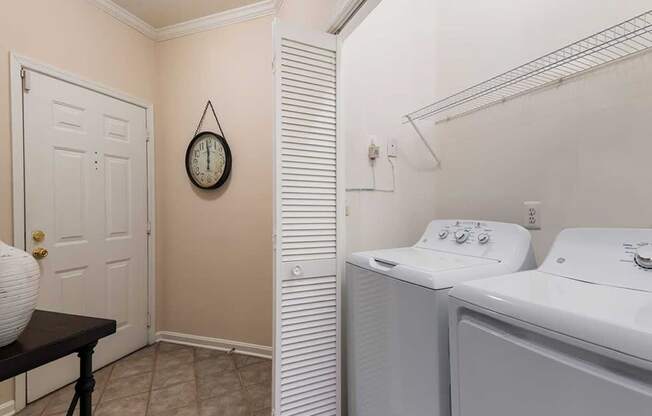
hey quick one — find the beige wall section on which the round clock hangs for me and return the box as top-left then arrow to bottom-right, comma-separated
156,17 -> 273,346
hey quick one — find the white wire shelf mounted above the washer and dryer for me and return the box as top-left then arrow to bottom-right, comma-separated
405,10 -> 652,123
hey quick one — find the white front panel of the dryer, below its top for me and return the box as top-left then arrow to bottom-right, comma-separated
453,317 -> 652,416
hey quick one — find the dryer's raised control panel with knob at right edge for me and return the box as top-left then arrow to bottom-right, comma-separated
540,228 -> 652,292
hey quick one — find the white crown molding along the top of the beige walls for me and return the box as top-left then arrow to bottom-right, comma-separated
89,0 -> 283,42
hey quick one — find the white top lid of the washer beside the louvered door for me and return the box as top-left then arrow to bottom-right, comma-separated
348,247 -> 500,289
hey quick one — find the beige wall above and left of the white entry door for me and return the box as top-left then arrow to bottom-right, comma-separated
0,0 -> 155,403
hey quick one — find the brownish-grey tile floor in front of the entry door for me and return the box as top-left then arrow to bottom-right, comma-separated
18,343 -> 272,416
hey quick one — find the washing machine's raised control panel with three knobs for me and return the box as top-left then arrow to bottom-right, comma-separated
415,220 -> 534,265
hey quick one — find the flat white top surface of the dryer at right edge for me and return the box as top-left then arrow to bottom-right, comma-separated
451,271 -> 652,362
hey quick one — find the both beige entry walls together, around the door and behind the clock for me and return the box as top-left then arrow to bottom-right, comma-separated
0,0 -> 272,354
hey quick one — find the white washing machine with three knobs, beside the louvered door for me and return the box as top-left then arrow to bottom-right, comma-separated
345,221 -> 536,416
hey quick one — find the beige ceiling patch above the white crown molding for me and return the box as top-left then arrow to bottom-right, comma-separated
113,0 -> 260,29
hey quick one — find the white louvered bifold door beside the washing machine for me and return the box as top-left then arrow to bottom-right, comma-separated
274,21 -> 343,416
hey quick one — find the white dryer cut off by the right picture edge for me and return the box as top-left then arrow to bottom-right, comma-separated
450,229 -> 652,416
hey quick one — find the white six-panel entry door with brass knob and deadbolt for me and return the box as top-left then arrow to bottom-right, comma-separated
23,71 -> 148,402
